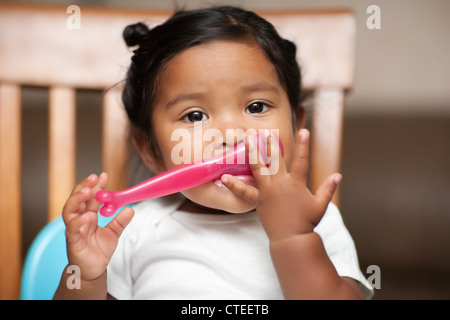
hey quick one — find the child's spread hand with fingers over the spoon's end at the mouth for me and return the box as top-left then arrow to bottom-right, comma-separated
221,129 -> 342,241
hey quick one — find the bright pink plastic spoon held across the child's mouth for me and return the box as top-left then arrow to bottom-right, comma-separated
95,134 -> 283,217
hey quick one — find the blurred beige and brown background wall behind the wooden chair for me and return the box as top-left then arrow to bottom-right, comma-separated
4,0 -> 450,299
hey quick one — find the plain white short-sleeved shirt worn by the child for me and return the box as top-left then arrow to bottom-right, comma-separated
108,196 -> 372,300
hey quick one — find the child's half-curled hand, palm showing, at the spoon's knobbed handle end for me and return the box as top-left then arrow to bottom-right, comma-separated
62,173 -> 134,281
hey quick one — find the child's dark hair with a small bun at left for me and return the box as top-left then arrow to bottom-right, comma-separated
122,6 -> 301,161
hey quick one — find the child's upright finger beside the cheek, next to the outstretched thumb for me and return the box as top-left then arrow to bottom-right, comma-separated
291,129 -> 310,183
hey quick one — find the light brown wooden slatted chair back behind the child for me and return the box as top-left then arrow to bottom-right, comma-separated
0,3 -> 355,299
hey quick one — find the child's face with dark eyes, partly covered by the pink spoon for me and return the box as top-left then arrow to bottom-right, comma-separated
151,41 -> 302,213
